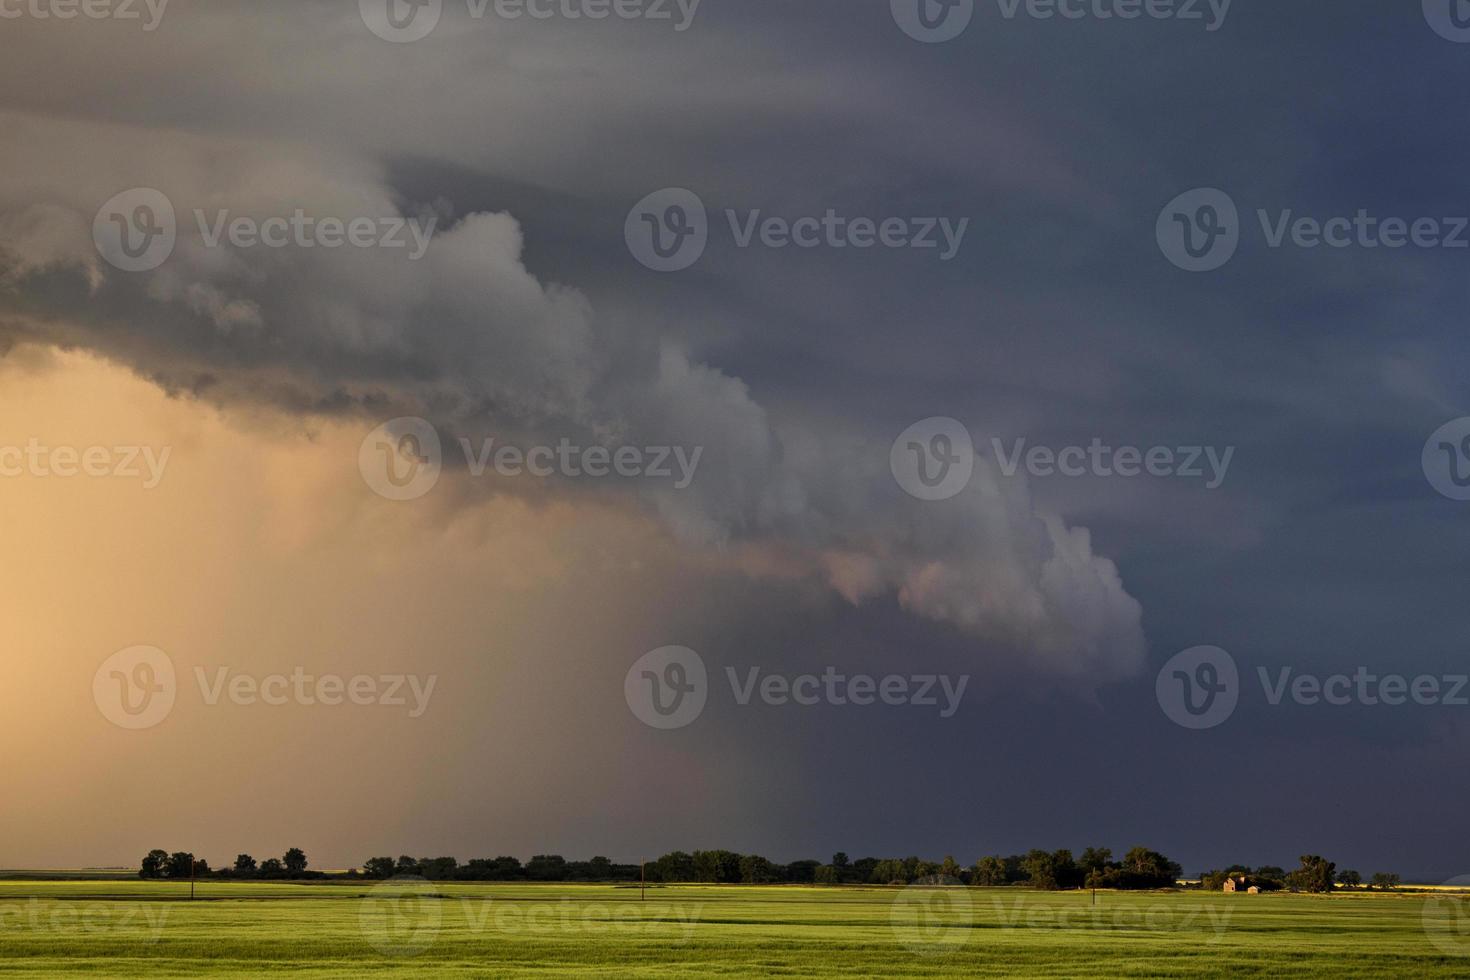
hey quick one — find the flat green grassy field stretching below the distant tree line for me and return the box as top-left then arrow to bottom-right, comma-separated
0,880 -> 1470,977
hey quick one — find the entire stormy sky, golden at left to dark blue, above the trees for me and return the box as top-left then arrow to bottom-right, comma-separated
0,0 -> 1470,880
